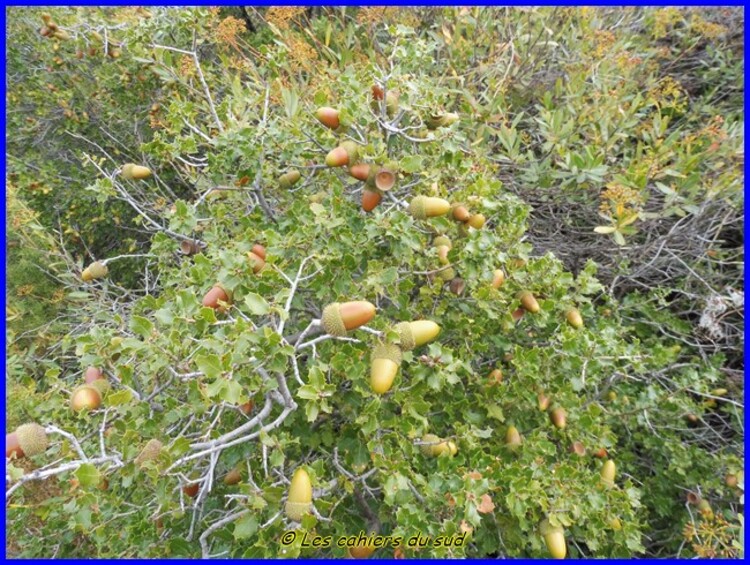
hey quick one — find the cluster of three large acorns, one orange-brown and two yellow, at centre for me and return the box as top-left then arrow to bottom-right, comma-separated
321,300 -> 440,394
